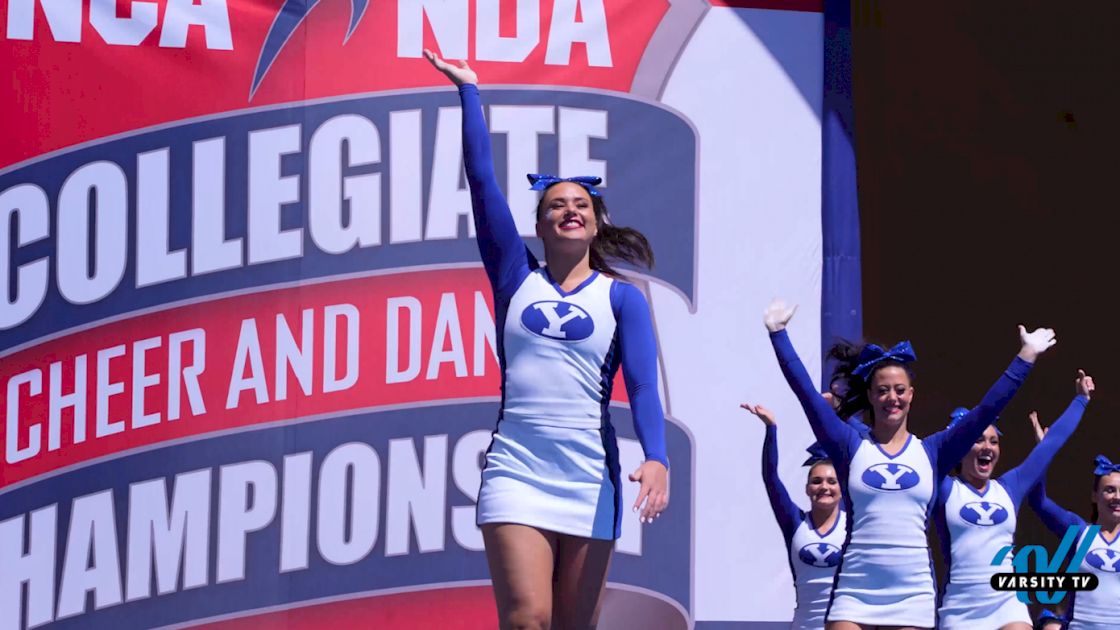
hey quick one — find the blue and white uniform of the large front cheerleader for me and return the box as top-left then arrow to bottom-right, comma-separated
459,84 -> 669,539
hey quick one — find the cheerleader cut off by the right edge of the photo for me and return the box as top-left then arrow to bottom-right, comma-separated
1028,413 -> 1120,630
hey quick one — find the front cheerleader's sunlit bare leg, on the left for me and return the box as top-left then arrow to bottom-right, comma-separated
482,522 -> 557,630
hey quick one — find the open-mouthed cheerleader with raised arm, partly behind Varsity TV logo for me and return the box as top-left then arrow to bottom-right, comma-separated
934,370 -> 1093,630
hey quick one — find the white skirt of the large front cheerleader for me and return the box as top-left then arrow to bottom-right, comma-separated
478,420 -> 622,540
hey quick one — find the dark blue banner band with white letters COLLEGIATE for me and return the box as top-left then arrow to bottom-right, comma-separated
0,90 -> 697,352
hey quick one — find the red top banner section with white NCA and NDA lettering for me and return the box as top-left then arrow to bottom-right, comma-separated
0,0 -> 669,168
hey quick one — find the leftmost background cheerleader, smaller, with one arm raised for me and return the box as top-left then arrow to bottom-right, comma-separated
741,405 -> 847,630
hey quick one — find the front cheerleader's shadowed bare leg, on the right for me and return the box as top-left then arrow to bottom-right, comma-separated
552,535 -> 615,630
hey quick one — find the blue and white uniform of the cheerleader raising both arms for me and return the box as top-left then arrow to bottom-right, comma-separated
771,331 -> 1032,628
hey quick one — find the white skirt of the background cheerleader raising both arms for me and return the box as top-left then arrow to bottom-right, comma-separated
828,544 -> 936,628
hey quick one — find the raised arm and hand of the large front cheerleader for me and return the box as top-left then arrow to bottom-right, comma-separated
423,50 -> 530,298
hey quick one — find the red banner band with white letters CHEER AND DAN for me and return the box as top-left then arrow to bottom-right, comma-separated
0,268 -> 626,488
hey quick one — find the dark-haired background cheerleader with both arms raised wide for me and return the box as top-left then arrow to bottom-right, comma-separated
764,302 -> 1055,630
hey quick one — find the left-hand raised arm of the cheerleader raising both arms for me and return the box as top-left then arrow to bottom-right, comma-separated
763,299 -> 861,462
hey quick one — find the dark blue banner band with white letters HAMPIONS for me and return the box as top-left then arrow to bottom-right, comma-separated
0,402 -> 693,630
